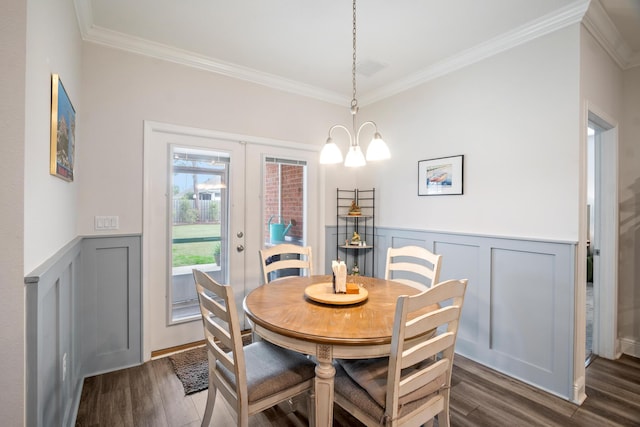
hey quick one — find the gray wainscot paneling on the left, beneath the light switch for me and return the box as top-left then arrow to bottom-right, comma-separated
25,236 -> 142,426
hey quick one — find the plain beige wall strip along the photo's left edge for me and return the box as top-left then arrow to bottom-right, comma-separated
0,0 -> 27,426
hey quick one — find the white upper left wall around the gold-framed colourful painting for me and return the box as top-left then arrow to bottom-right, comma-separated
24,0 -> 82,274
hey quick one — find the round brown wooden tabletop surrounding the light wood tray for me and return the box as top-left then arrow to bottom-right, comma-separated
244,276 -> 433,345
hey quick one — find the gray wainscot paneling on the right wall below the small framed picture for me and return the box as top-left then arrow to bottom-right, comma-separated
325,227 -> 576,400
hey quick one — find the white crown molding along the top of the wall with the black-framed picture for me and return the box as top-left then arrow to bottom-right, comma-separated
362,0 -> 589,105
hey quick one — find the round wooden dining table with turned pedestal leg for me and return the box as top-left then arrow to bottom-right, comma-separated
243,275 -> 437,427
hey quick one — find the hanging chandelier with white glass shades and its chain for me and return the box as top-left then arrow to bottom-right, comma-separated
320,0 -> 391,167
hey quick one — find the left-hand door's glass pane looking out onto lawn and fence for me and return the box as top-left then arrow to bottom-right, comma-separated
169,146 -> 229,323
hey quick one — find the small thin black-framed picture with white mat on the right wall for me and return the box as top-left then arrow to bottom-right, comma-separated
418,155 -> 464,196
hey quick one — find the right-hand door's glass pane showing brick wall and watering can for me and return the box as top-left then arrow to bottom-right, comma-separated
262,157 -> 307,280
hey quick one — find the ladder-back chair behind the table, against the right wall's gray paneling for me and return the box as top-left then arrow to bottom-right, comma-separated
384,246 -> 442,290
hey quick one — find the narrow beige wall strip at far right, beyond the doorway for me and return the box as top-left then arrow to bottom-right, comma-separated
618,66 -> 640,357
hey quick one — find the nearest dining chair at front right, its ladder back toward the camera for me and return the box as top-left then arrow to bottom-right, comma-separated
334,279 -> 467,427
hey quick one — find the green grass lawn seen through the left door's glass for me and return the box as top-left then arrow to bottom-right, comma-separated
172,224 -> 220,267
